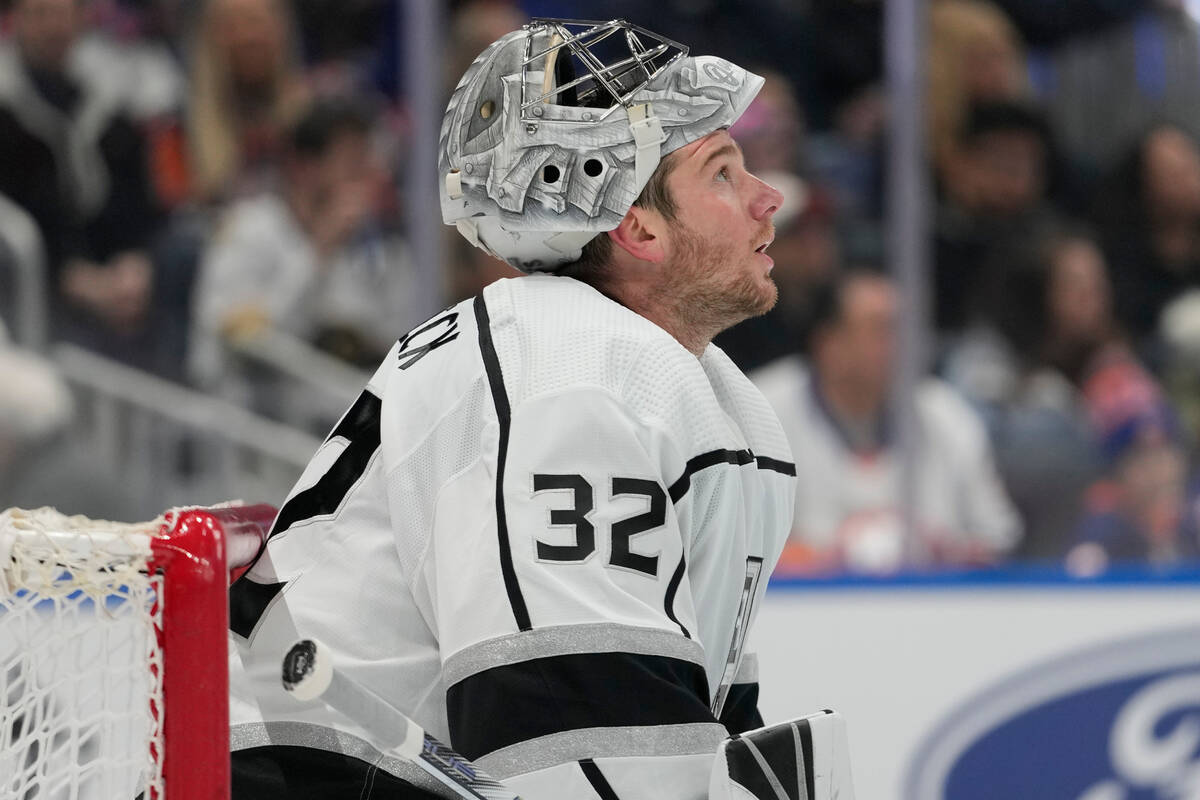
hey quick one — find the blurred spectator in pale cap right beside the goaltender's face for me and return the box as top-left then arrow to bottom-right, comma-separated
714,172 -> 842,371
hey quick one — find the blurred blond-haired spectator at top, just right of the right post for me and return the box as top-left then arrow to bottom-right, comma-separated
926,0 -> 1027,179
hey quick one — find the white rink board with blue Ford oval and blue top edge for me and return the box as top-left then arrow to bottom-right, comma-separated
752,569 -> 1200,800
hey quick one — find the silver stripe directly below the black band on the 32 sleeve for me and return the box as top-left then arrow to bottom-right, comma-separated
475,722 -> 730,781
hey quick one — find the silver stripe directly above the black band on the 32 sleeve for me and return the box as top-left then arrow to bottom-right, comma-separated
442,622 -> 704,686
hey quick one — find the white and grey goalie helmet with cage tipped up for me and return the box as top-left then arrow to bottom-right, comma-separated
438,19 -> 762,272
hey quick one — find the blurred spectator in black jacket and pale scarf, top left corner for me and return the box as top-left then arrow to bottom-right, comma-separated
0,0 -> 175,368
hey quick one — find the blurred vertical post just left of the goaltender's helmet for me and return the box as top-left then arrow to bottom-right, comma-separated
396,0 -> 445,323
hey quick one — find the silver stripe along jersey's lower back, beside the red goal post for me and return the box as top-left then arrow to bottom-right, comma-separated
229,722 -> 445,794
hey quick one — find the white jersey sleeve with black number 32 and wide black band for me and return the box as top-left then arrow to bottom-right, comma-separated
422,387 -> 727,800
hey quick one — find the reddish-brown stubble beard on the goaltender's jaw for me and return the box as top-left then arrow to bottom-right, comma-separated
662,223 -> 779,339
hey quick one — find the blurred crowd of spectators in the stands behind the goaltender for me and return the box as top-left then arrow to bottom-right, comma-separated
7,0 -> 1200,572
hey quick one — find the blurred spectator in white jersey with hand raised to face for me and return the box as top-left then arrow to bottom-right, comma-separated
194,100 -> 414,398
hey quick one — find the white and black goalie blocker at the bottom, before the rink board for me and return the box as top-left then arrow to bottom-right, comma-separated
708,710 -> 854,800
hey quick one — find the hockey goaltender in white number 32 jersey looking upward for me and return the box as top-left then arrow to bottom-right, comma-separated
230,19 -> 852,800
